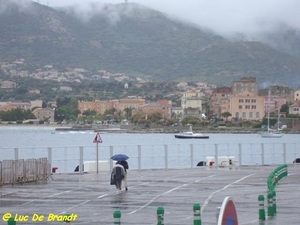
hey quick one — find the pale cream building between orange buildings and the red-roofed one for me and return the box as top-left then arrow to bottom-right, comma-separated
181,88 -> 206,118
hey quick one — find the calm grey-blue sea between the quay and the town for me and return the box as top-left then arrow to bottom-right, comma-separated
0,126 -> 300,170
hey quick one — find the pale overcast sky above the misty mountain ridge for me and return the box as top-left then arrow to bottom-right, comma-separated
39,0 -> 300,36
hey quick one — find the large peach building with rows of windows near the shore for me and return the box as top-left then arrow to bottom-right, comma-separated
229,91 -> 265,120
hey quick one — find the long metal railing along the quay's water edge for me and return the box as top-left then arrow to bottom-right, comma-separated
2,143 -> 300,176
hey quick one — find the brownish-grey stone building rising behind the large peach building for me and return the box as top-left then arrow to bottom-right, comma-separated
232,77 -> 258,94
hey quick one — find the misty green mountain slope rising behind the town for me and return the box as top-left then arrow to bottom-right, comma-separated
0,0 -> 300,87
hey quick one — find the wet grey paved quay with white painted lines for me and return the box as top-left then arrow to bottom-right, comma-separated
0,164 -> 300,225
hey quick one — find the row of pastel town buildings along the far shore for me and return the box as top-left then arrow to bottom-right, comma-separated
0,74 -> 300,128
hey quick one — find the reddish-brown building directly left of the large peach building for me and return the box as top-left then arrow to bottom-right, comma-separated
208,87 -> 232,118
